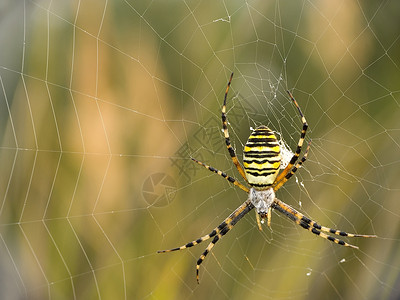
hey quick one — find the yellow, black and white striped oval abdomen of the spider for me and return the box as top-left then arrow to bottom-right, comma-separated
243,126 -> 281,190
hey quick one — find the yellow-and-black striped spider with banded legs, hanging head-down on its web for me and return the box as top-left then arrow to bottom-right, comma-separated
158,73 -> 376,283
